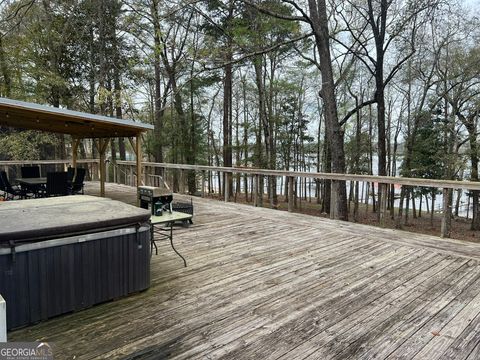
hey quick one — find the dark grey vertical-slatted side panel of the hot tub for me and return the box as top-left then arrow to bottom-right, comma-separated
0,229 -> 150,329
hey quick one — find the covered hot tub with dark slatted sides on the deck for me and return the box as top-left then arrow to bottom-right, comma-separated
0,195 -> 150,329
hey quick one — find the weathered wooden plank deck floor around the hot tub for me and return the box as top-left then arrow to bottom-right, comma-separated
7,186 -> 480,360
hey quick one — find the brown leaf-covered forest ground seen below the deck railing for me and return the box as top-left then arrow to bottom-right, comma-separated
211,195 -> 480,243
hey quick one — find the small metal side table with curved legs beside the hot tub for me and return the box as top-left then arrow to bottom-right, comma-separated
150,211 -> 193,267
